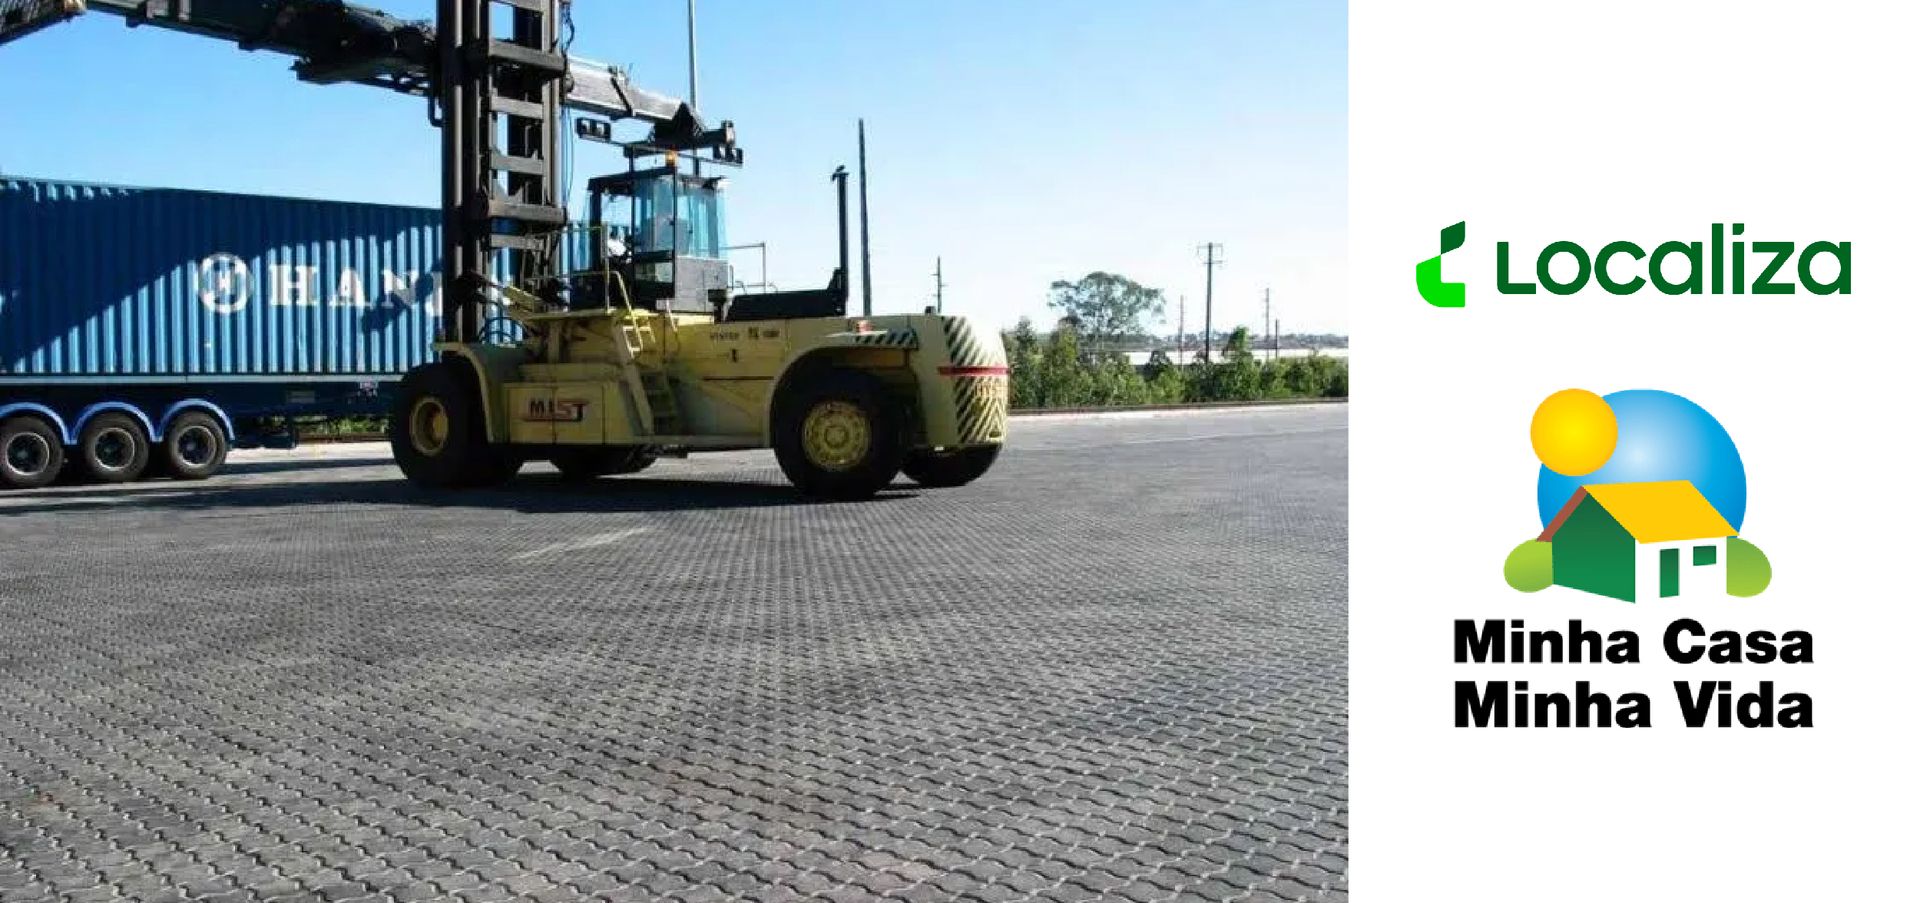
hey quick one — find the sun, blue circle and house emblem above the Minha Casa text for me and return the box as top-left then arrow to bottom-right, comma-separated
1505,388 -> 1772,601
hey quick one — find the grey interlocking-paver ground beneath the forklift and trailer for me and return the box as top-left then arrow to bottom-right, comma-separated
0,407 -> 1348,901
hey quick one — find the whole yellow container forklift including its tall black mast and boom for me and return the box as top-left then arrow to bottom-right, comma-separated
0,0 -> 1008,500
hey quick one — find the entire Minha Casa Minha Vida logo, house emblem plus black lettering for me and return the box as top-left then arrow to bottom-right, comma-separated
1453,388 -> 1812,728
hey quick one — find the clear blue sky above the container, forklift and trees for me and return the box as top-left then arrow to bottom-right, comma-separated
0,0 -> 1346,332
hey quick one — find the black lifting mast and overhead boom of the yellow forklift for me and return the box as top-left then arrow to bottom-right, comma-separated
0,0 -> 737,342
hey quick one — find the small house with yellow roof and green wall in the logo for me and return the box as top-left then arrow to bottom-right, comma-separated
1540,480 -> 1734,601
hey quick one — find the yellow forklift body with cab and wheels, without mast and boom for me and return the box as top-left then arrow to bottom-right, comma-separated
392,144 -> 1006,498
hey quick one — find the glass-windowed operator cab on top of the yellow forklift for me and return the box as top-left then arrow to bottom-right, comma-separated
570,163 -> 730,313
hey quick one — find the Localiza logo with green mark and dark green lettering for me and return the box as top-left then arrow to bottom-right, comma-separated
1413,223 -> 1853,307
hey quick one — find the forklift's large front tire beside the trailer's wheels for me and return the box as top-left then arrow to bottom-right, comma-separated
388,363 -> 522,488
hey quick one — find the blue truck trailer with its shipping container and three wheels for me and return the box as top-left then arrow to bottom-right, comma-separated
0,177 -> 445,488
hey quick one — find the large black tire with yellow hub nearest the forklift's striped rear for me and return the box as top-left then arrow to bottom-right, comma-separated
774,369 -> 904,500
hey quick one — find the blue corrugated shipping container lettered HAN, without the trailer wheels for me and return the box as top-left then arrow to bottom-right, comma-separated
0,179 -> 440,376
